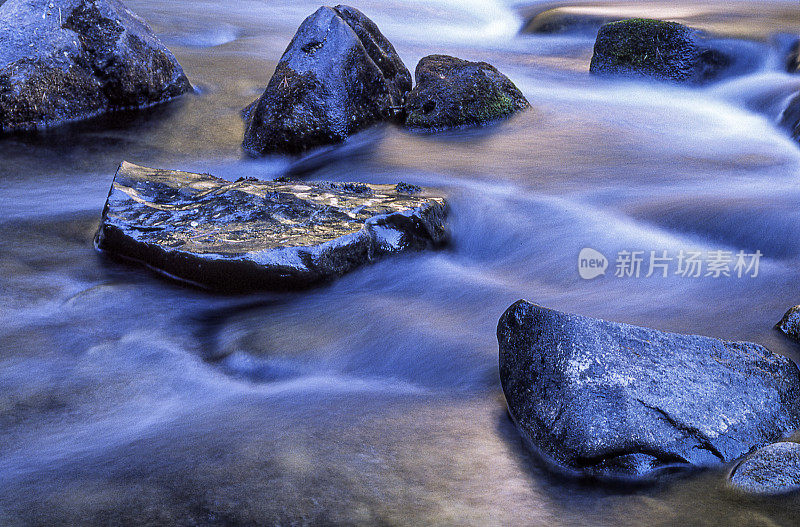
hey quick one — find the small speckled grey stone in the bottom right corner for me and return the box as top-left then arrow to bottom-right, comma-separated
731,443 -> 800,494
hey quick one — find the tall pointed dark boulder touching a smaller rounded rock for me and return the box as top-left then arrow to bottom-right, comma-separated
243,5 -> 411,155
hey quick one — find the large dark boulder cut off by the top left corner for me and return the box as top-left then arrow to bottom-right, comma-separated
0,0 -> 192,131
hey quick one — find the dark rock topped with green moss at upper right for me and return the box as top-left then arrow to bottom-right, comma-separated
589,18 -> 737,84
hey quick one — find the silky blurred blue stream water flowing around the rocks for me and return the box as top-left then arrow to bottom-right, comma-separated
0,0 -> 800,526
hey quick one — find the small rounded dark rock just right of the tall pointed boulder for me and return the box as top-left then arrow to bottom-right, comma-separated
405,55 -> 530,131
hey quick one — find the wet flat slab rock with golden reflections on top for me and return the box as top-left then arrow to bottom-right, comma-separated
95,163 -> 446,291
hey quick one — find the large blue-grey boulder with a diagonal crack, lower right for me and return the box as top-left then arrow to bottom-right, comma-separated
497,300 -> 800,478
